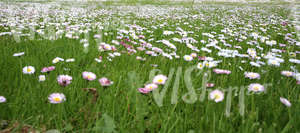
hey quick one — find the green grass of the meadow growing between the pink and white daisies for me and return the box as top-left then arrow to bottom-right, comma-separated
0,1 -> 300,133
